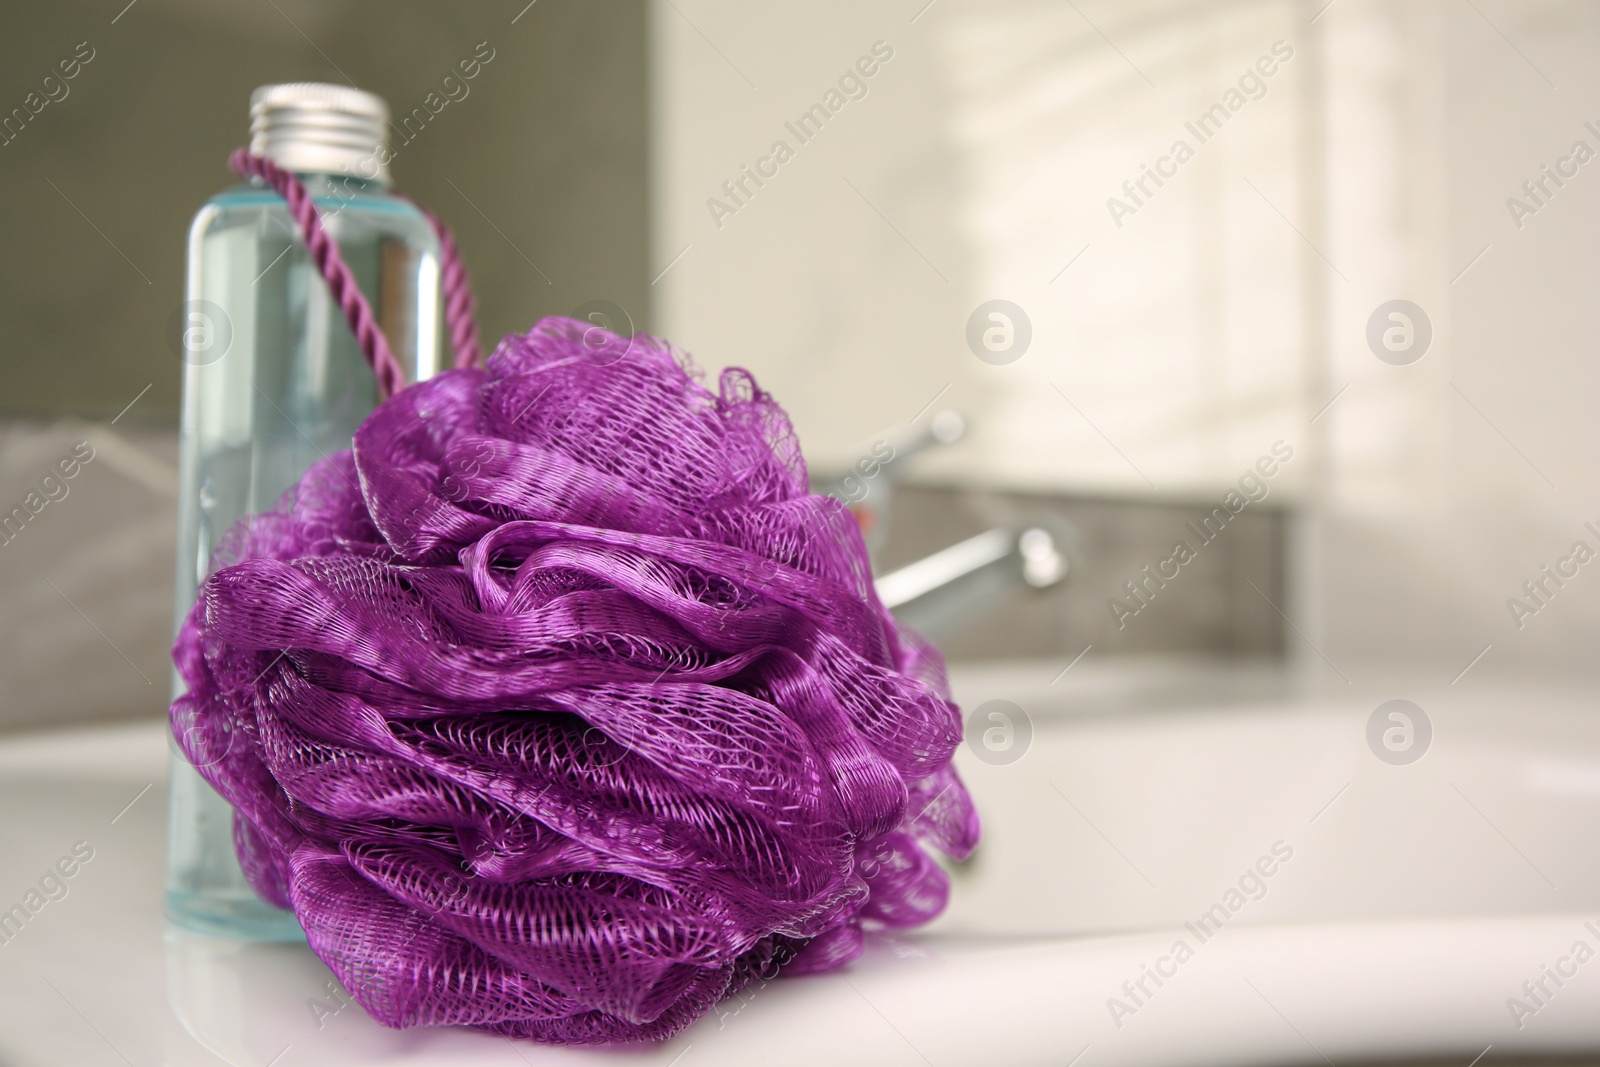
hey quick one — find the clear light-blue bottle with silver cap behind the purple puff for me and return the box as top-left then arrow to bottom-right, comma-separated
166,83 -> 440,939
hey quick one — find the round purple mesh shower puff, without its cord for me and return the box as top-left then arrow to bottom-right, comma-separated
171,318 -> 978,1043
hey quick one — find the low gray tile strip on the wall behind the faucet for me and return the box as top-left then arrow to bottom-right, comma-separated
875,485 -> 1293,661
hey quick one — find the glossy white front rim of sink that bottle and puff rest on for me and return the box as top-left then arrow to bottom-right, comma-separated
9,687 -> 1600,1067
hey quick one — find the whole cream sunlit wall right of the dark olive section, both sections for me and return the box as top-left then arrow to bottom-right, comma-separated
651,0 -> 1600,683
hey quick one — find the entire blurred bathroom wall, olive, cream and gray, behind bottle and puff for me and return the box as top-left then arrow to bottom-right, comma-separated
0,0 -> 1600,735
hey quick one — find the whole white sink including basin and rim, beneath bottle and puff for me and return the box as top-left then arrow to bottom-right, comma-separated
0,665 -> 1600,1067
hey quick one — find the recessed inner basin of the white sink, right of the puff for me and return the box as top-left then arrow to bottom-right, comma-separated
931,671 -> 1600,940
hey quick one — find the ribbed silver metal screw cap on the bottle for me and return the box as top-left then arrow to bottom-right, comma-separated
250,82 -> 389,184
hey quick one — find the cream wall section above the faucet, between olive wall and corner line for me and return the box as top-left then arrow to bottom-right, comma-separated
653,0 -> 1323,494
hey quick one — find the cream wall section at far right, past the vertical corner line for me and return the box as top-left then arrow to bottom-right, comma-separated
1307,0 -> 1600,685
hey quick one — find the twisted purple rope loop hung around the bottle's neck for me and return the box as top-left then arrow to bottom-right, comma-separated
227,149 -> 483,400
